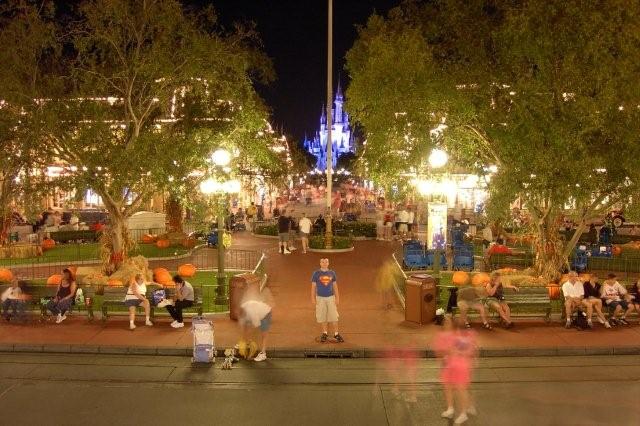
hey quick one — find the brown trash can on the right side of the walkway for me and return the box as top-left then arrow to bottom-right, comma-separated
404,274 -> 437,324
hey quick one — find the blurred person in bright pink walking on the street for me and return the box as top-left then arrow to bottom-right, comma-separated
434,315 -> 478,424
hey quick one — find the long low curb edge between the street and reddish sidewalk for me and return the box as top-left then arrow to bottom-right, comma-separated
0,343 -> 640,358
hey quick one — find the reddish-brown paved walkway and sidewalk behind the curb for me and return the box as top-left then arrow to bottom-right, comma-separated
0,234 -> 640,357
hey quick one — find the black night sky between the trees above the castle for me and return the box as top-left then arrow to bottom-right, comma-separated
191,0 -> 400,142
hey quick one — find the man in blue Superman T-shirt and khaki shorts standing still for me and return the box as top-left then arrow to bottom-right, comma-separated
311,258 -> 344,343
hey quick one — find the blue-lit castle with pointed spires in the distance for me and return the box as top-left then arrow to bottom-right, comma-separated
302,83 -> 356,170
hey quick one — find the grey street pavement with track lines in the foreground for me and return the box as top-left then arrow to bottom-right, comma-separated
0,353 -> 640,426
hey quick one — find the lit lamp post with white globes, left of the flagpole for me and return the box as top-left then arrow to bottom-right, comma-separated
200,149 -> 241,305
